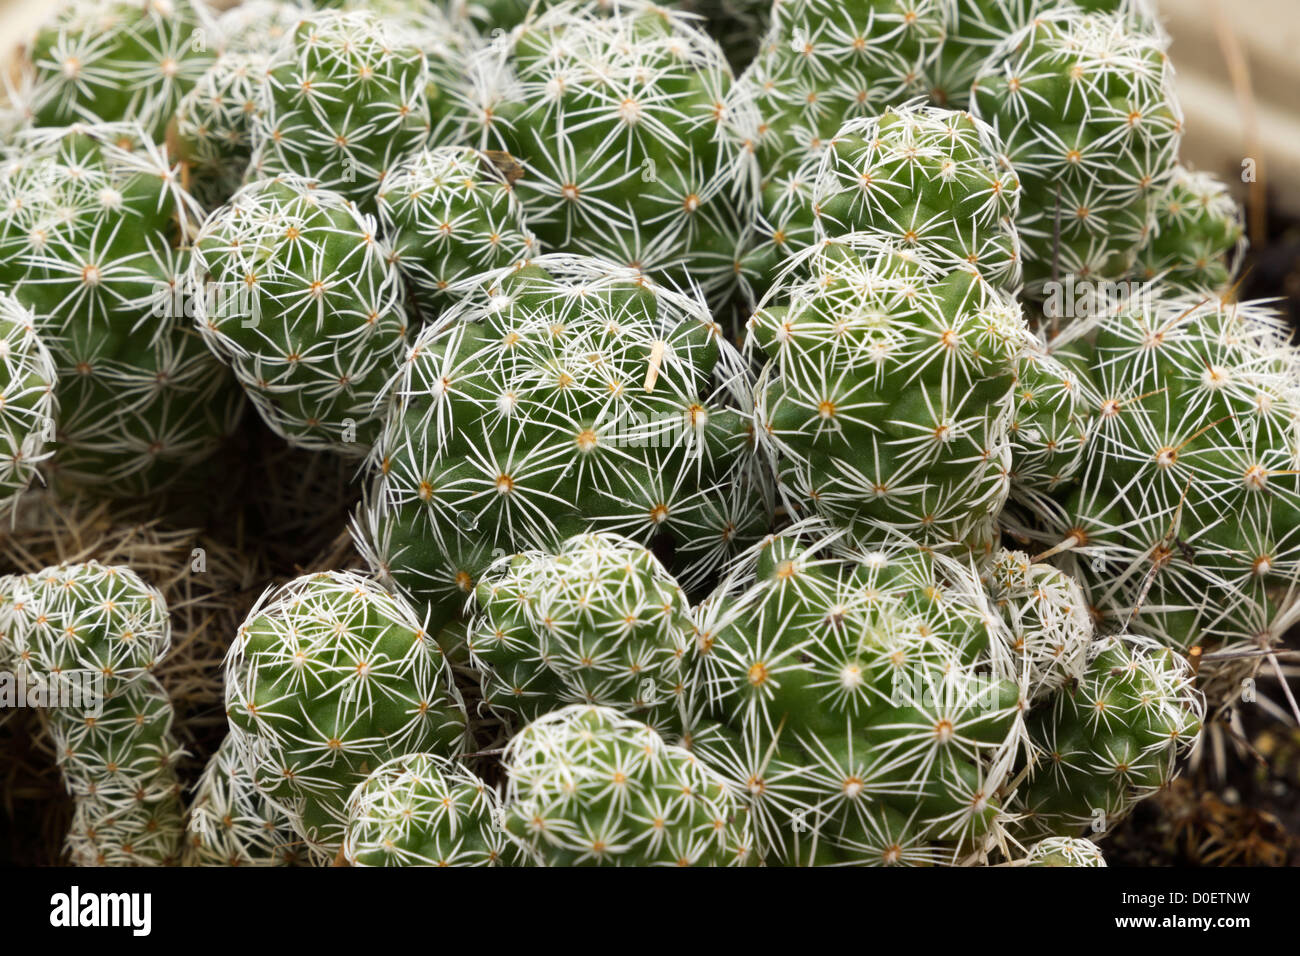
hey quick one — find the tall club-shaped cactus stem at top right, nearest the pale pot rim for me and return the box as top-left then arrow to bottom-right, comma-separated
972,8 -> 1183,298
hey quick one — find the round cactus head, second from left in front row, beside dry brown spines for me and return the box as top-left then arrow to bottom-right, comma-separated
225,571 -> 467,858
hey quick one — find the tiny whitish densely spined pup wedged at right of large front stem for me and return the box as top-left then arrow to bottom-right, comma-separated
985,549 -> 1093,704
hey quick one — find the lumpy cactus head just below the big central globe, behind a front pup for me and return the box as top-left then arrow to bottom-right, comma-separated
467,533 -> 696,737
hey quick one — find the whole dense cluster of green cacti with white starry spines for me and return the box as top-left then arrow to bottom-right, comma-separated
0,0 -> 1284,866
